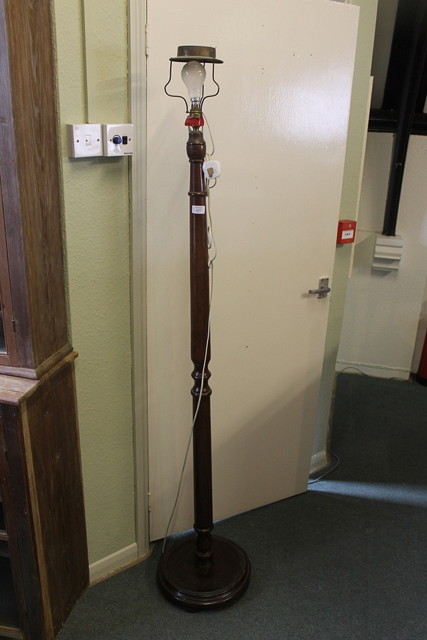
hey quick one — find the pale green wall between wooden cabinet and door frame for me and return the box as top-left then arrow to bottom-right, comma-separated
53,0 -> 135,562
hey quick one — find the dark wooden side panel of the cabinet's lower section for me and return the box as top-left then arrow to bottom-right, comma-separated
23,361 -> 89,634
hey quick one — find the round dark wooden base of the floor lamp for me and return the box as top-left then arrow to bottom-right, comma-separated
157,536 -> 251,611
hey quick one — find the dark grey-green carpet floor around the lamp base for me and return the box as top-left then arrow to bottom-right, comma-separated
58,374 -> 427,640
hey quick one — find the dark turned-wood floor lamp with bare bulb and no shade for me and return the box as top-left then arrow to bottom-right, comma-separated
157,46 -> 250,611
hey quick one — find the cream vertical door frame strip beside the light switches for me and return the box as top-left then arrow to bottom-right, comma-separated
128,0 -> 150,557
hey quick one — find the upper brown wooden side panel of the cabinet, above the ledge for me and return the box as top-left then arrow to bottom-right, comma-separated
0,0 -> 71,369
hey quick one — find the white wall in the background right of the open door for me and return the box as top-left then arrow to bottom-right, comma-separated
337,133 -> 427,379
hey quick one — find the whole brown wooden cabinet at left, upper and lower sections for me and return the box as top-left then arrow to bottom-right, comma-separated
0,0 -> 88,640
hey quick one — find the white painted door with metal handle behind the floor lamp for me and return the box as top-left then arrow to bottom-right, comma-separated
147,0 -> 358,539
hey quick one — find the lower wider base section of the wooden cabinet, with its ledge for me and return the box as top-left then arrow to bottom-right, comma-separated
0,354 -> 88,640
